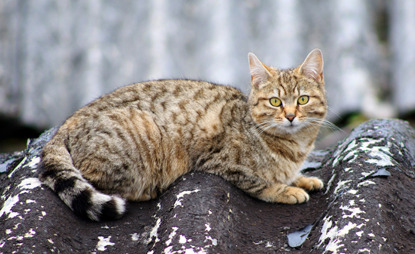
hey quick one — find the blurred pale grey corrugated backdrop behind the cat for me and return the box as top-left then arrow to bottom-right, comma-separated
0,0 -> 415,152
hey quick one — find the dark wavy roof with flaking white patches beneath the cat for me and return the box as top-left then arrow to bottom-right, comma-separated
0,120 -> 415,253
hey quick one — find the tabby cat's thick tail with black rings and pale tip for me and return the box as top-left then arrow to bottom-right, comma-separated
39,137 -> 126,221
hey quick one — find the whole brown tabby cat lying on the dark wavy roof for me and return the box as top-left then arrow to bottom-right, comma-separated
40,49 -> 327,221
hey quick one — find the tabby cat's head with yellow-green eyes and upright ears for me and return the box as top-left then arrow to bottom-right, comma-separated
248,49 -> 327,135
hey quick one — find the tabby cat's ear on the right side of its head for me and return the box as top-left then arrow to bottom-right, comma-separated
297,49 -> 324,82
